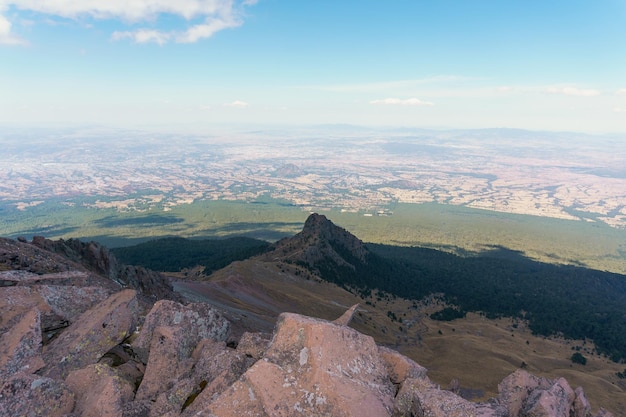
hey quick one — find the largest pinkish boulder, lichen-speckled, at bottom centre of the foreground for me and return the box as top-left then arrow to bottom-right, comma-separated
204,313 -> 395,417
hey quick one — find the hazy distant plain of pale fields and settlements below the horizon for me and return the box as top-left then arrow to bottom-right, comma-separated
0,126 -> 626,228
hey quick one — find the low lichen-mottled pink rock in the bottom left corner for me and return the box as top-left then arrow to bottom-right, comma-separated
0,373 -> 74,417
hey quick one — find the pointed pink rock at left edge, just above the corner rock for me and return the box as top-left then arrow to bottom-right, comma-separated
0,308 -> 45,380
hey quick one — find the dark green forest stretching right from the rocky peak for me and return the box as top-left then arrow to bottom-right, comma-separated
309,243 -> 626,362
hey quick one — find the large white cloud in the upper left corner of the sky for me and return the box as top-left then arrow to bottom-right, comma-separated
0,0 -> 256,45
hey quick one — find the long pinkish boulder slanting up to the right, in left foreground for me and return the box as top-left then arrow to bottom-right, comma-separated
43,290 -> 139,379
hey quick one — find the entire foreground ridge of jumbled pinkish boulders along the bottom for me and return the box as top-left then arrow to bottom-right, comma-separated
0,236 -> 612,417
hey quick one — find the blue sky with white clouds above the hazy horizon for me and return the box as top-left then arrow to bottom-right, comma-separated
0,0 -> 626,133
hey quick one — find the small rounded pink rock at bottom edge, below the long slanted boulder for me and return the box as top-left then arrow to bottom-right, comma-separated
65,364 -> 135,417
